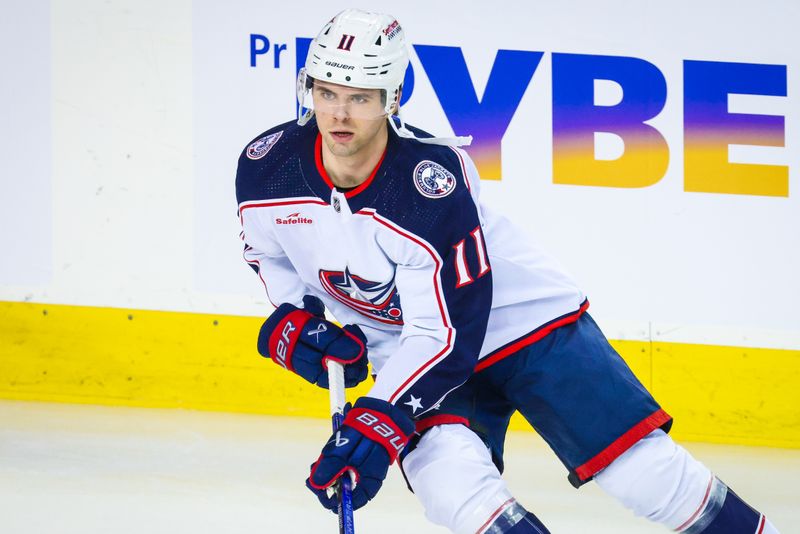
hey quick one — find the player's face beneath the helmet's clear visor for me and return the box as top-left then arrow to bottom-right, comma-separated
312,81 -> 386,157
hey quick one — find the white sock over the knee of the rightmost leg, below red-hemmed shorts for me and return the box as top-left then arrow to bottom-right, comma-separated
595,430 -> 712,529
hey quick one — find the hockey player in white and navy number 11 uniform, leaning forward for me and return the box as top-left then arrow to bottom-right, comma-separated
236,10 -> 777,534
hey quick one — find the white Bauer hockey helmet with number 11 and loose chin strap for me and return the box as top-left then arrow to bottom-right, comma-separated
297,9 -> 472,145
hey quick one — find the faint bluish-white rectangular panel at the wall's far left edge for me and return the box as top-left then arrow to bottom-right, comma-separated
0,0 -> 53,288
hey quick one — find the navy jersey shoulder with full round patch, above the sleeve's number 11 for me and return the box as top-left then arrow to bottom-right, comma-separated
374,126 -> 478,253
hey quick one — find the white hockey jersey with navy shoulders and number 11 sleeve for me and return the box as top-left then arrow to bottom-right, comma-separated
236,121 -> 587,417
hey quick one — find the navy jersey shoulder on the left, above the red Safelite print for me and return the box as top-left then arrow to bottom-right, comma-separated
236,120 -> 316,204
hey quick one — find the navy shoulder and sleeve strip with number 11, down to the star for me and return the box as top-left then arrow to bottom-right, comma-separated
374,128 -> 492,417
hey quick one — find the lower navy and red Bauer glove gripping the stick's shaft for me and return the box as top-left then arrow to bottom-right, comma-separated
306,397 -> 414,513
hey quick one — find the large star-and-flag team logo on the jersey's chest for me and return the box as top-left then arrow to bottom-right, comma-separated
319,268 -> 403,325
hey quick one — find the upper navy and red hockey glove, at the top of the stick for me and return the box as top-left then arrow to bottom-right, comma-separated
258,295 -> 367,389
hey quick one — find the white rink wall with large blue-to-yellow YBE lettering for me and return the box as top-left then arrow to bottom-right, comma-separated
0,0 -> 800,349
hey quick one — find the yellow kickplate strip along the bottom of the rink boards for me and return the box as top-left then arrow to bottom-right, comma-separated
0,302 -> 800,448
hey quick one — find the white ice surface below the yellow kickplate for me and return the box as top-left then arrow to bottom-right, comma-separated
0,401 -> 800,534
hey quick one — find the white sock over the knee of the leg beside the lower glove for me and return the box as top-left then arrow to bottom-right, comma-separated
403,425 -> 511,534
